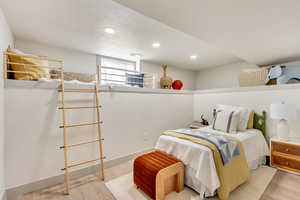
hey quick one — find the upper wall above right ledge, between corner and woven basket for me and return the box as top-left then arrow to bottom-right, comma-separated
196,62 -> 258,90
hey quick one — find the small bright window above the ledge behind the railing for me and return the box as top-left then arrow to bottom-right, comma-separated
100,56 -> 144,87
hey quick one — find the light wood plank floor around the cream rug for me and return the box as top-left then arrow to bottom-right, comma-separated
18,161 -> 300,200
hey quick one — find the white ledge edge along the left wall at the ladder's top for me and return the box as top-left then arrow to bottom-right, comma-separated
4,79 -> 194,95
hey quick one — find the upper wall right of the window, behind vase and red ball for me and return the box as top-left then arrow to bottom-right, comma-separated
141,62 -> 197,90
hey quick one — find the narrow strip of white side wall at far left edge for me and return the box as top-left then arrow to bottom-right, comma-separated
0,8 -> 13,199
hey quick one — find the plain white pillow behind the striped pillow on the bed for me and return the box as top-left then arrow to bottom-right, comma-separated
217,104 -> 251,131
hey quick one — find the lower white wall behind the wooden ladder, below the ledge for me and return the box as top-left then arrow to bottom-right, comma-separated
5,87 -> 193,188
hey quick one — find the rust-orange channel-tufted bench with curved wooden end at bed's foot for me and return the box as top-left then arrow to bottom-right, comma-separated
133,151 -> 184,200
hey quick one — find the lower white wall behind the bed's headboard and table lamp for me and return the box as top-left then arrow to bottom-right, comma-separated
194,86 -> 300,141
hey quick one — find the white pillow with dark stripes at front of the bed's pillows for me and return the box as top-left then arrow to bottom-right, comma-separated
212,110 -> 240,133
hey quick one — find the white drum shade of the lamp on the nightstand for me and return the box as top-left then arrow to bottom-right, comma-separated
270,103 -> 296,120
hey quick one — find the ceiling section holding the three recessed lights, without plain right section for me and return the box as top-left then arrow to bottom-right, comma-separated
0,0 -> 241,70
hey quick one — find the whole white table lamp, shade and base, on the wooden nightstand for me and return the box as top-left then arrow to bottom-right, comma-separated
270,103 -> 296,139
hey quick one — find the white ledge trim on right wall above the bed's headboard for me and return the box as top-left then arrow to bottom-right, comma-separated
194,84 -> 300,94
